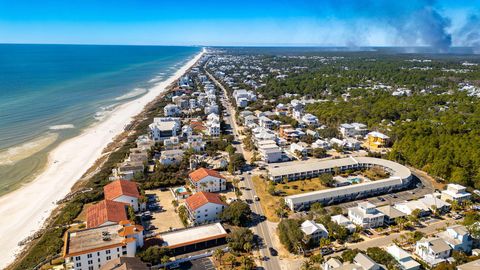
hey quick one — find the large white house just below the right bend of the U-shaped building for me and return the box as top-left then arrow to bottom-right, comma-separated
348,202 -> 385,229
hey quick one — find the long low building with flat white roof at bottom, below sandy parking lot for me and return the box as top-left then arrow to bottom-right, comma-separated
159,223 -> 228,255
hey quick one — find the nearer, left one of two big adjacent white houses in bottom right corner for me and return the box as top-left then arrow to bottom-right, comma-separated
415,237 -> 452,266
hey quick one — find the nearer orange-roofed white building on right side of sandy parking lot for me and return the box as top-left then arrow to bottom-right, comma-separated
185,191 -> 227,224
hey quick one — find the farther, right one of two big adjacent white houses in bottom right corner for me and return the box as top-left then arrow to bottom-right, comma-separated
436,225 -> 473,253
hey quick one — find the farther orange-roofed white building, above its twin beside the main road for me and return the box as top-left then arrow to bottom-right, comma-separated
188,168 -> 227,192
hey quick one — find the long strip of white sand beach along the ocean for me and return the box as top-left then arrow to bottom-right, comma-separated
0,48 -> 203,269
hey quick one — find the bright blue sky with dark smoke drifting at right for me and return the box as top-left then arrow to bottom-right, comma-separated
0,0 -> 480,47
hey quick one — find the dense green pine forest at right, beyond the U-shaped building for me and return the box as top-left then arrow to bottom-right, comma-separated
307,92 -> 480,188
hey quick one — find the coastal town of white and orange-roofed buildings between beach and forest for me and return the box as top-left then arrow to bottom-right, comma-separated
8,48 -> 480,270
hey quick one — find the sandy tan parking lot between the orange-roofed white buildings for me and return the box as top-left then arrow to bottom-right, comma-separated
142,189 -> 183,232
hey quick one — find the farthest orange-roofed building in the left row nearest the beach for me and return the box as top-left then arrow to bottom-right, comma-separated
103,180 -> 145,212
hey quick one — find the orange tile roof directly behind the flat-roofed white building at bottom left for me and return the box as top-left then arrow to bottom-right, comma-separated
87,200 -> 128,228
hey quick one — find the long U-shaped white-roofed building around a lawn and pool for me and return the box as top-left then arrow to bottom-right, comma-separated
268,157 -> 412,211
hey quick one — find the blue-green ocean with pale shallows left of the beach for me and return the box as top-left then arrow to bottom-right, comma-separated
0,44 -> 201,195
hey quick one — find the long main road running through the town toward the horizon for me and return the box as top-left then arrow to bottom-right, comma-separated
207,68 -> 280,270
